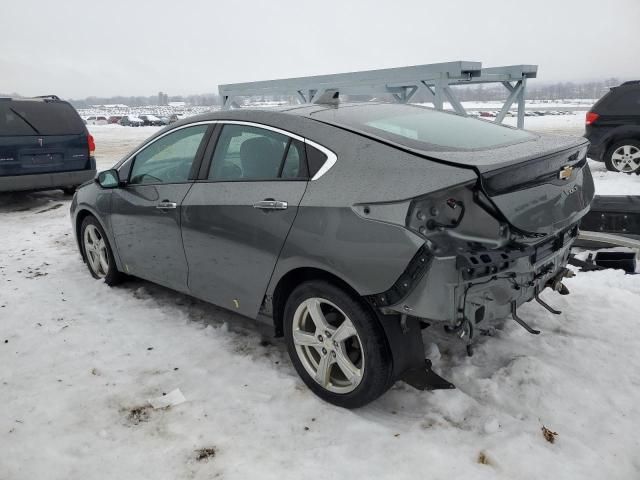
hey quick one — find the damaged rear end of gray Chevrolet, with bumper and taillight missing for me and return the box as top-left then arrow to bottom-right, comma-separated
364,140 -> 593,344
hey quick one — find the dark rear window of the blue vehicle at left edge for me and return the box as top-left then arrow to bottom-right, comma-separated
0,100 -> 85,136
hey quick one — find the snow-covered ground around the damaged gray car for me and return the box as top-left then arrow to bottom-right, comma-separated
0,116 -> 640,480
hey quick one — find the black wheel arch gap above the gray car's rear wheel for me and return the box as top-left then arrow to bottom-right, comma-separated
271,267 -> 370,337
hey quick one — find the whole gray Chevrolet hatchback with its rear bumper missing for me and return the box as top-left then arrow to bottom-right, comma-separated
71,103 -> 593,408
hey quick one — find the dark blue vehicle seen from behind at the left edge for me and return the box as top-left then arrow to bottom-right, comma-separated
0,95 -> 96,194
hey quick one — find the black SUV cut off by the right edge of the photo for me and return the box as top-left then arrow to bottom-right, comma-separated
585,80 -> 640,174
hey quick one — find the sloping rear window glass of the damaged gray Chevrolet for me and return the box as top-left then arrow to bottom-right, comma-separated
312,104 -> 534,151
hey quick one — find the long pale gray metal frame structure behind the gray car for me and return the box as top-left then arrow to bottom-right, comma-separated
218,61 -> 538,128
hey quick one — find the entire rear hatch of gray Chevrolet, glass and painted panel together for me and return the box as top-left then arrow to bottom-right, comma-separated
309,103 -> 594,236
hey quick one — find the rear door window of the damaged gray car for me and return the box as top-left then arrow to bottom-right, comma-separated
208,125 -> 307,181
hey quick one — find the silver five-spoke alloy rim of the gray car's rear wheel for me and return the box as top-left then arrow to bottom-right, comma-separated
292,297 -> 365,394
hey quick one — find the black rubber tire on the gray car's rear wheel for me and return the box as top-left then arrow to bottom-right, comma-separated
283,280 -> 393,408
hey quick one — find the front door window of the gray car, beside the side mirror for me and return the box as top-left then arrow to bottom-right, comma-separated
129,125 -> 208,185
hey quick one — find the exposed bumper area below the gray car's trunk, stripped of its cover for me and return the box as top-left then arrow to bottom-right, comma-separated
386,225 -> 578,327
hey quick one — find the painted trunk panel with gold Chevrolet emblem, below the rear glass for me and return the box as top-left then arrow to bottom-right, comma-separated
421,136 -> 594,235
